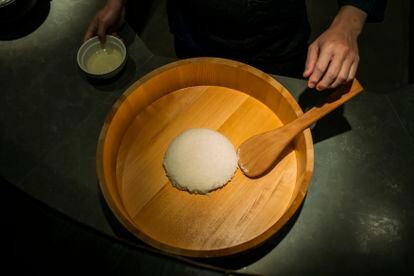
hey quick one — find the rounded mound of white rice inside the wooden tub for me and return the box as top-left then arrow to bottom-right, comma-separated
164,128 -> 237,194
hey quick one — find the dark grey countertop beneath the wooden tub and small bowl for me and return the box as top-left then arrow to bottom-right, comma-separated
0,0 -> 414,275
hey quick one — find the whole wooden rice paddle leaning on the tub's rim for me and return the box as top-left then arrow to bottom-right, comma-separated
237,79 -> 363,178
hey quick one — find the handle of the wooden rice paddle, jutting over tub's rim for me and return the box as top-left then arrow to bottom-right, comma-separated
289,79 -> 363,134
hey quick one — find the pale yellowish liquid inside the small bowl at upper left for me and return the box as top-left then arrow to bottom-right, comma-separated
86,48 -> 122,75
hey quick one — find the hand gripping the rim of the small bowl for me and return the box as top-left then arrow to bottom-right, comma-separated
83,0 -> 125,42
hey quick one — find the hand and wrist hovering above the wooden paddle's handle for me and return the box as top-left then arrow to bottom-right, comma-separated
303,6 -> 367,90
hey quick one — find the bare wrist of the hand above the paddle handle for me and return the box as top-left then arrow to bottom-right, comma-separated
331,5 -> 367,37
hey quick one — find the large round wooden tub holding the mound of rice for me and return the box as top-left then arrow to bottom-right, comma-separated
97,58 -> 313,257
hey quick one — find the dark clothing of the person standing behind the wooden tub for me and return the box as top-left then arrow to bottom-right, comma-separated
167,0 -> 385,77
